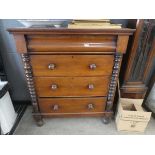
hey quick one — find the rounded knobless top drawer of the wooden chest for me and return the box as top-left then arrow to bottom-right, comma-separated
26,34 -> 117,52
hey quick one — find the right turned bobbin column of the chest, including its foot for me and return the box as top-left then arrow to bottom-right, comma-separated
103,53 -> 122,124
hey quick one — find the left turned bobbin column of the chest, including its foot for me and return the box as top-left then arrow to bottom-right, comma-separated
21,53 -> 43,126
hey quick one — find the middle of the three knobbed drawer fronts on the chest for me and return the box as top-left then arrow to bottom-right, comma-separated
34,76 -> 110,97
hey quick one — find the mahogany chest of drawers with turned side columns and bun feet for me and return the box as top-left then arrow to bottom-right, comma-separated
8,28 -> 134,125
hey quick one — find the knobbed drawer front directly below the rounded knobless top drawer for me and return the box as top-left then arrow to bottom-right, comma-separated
31,55 -> 114,76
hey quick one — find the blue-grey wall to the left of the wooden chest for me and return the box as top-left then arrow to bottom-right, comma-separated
0,20 -> 30,101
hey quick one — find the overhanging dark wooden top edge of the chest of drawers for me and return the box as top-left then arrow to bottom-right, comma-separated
8,27 -> 135,36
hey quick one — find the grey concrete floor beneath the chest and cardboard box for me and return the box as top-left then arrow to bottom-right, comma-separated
14,106 -> 155,135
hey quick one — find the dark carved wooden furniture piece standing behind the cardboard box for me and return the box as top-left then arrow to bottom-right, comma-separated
121,19 -> 155,98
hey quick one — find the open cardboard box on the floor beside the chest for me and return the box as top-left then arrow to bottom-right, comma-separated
116,98 -> 151,132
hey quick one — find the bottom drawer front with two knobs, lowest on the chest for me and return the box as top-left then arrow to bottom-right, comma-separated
39,97 -> 106,114
